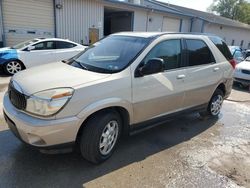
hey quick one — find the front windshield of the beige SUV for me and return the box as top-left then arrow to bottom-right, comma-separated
72,36 -> 150,73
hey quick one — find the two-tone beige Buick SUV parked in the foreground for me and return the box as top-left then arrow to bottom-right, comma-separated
4,32 -> 235,163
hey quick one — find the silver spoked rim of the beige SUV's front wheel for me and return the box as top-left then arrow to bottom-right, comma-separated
99,120 -> 119,155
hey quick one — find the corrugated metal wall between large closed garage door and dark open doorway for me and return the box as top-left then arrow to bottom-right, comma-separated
56,0 -> 104,44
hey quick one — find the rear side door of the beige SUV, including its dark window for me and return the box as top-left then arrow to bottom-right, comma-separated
184,39 -> 223,108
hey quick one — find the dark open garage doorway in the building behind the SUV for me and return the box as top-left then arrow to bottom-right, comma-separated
104,7 -> 133,36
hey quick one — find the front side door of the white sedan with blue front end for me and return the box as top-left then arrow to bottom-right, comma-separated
22,41 -> 56,68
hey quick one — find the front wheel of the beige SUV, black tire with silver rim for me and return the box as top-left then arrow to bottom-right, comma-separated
80,111 -> 122,164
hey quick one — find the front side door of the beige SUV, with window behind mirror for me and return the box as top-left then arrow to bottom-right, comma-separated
132,39 -> 186,123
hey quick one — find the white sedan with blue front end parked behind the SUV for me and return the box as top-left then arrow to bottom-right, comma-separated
0,38 -> 86,75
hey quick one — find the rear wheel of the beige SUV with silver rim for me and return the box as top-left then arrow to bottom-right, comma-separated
200,89 -> 224,117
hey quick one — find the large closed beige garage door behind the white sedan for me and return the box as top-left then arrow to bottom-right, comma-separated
3,0 -> 54,46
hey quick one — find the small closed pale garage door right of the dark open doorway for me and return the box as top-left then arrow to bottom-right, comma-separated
162,17 -> 180,32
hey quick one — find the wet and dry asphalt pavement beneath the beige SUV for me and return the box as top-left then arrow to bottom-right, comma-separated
0,78 -> 250,188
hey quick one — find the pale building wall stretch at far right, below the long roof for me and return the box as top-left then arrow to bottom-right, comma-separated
204,24 -> 250,48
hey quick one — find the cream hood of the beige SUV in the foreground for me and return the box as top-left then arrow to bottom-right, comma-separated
12,62 -> 110,95
